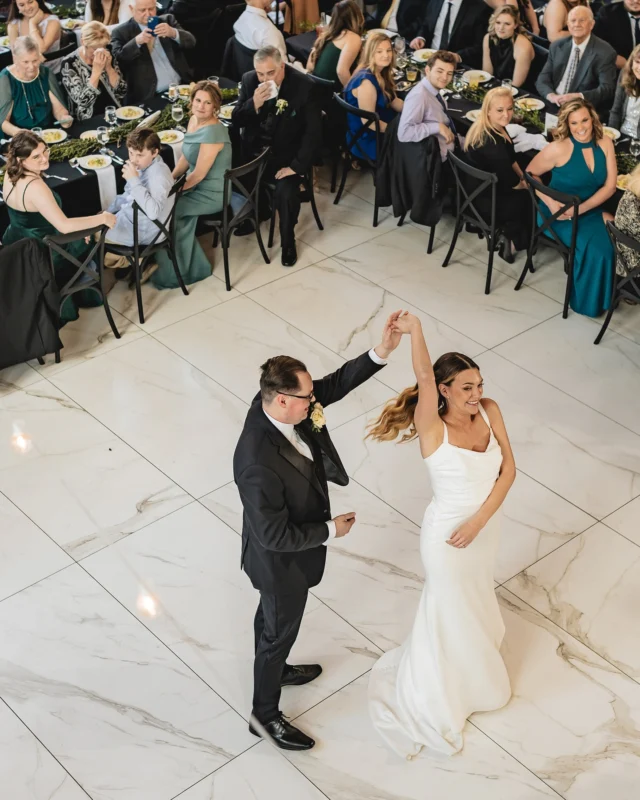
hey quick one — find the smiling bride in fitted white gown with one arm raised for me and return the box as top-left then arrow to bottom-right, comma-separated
369,314 -> 515,759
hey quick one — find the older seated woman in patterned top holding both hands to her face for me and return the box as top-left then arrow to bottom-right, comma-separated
60,22 -> 127,119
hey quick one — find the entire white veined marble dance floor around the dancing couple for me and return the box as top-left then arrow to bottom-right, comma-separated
0,169 -> 640,800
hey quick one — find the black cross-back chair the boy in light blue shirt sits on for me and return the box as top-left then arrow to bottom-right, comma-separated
105,174 -> 189,325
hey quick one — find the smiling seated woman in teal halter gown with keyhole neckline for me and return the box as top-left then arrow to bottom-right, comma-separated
528,98 -> 618,317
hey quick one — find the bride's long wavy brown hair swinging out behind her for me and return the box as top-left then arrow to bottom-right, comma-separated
365,353 -> 480,444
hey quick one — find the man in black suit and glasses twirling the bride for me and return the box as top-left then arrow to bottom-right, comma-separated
233,311 -> 401,750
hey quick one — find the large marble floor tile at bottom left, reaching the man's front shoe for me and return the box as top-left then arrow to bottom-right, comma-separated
0,565 -> 255,800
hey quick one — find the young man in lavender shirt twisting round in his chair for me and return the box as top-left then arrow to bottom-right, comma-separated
398,50 -> 458,161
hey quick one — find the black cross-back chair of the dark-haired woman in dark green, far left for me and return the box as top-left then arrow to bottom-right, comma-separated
43,225 -> 120,364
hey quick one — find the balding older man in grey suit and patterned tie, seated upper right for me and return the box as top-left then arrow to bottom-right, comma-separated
536,6 -> 616,111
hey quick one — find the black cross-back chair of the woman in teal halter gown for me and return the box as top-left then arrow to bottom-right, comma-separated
514,172 -> 580,319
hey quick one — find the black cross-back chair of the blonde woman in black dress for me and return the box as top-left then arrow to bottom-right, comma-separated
442,152 -> 502,294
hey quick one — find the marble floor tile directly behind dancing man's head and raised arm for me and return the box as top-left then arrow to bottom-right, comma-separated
156,297 -> 393,428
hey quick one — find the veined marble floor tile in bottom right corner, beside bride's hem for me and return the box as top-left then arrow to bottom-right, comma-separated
471,592 -> 640,800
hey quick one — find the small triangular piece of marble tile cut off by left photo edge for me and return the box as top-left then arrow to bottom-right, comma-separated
0,494 -> 73,600
